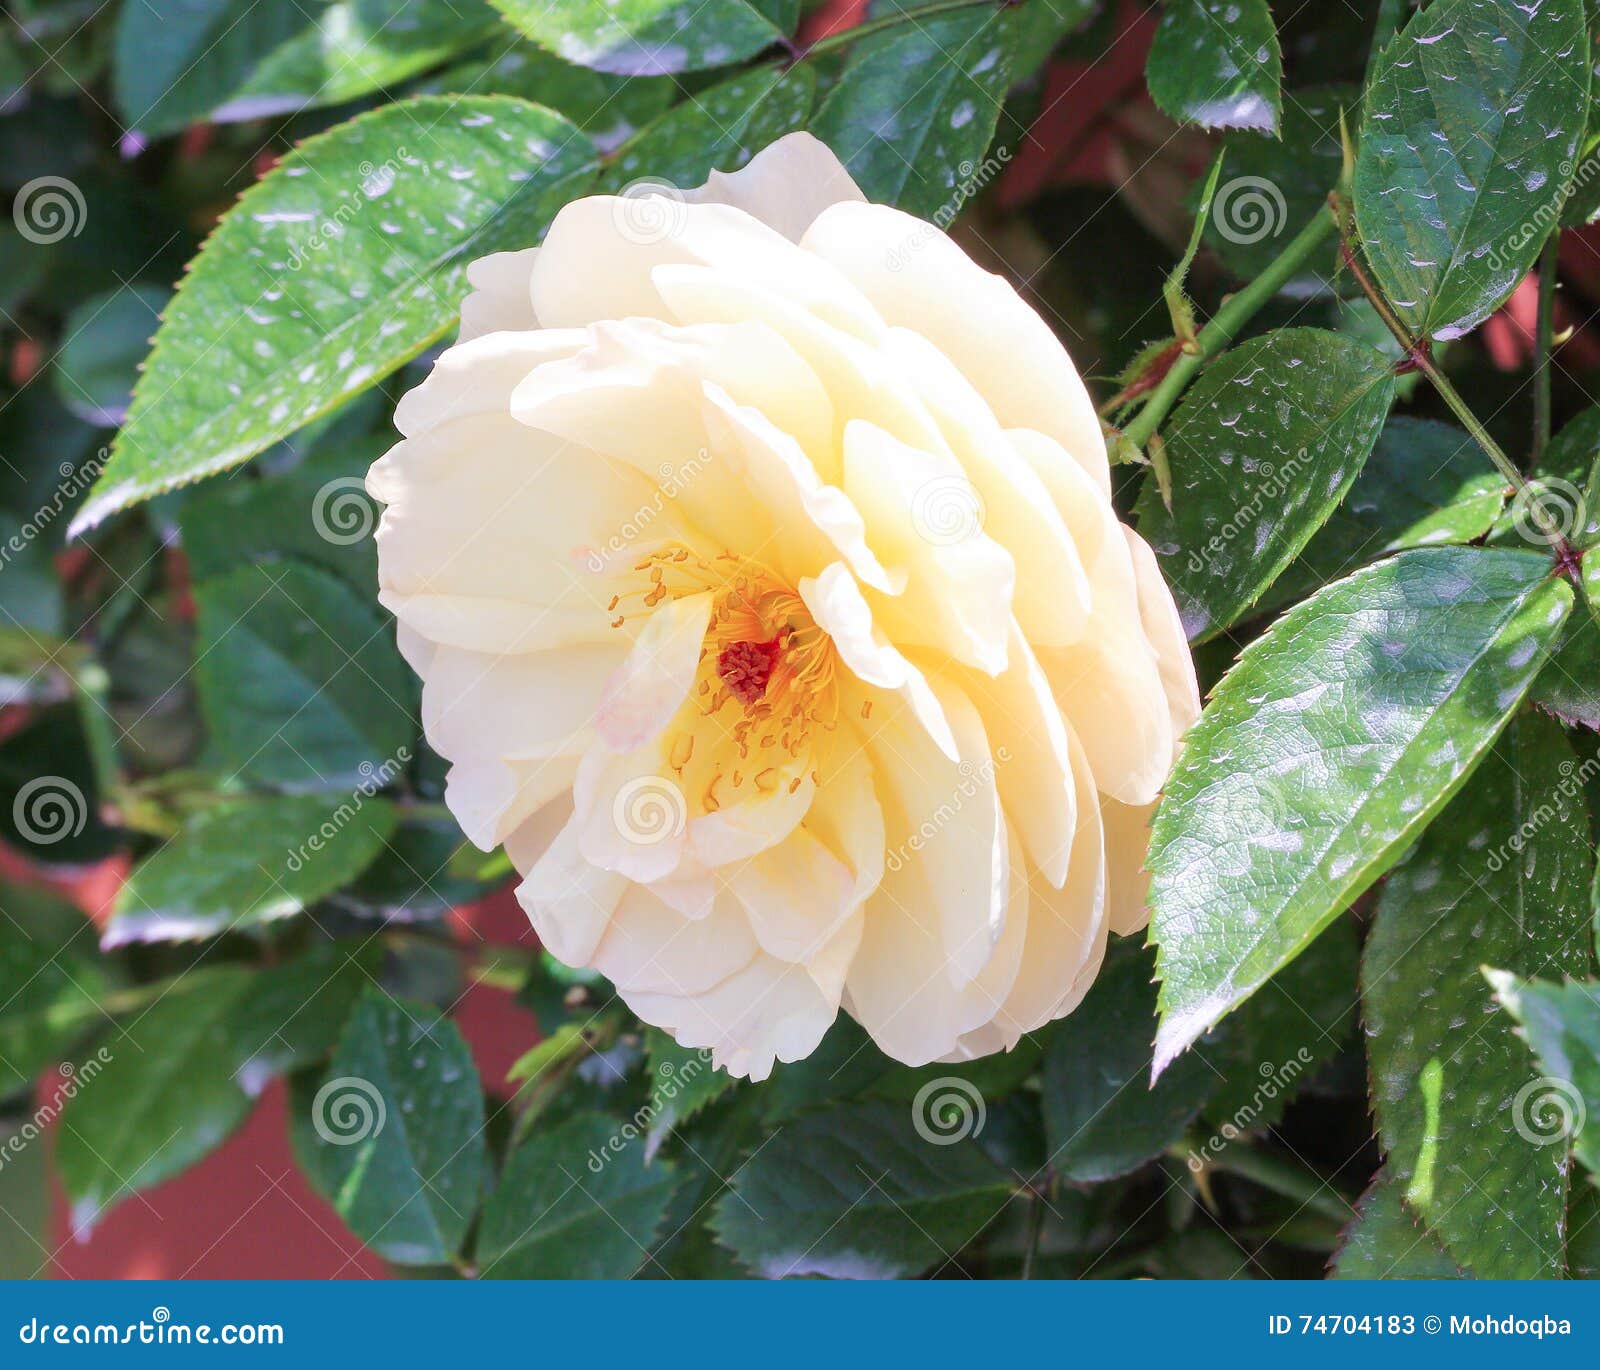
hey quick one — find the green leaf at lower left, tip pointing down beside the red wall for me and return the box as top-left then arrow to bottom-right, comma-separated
56,967 -> 254,1236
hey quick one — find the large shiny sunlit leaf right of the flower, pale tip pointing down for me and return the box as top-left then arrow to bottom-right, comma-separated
1149,547 -> 1571,1071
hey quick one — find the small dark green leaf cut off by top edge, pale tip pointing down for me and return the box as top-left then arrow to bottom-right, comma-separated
1144,0 -> 1283,133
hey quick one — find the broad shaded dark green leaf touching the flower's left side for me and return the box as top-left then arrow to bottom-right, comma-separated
195,562 -> 416,789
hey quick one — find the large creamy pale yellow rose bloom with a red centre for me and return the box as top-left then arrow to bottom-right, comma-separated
368,134 -> 1198,1079
